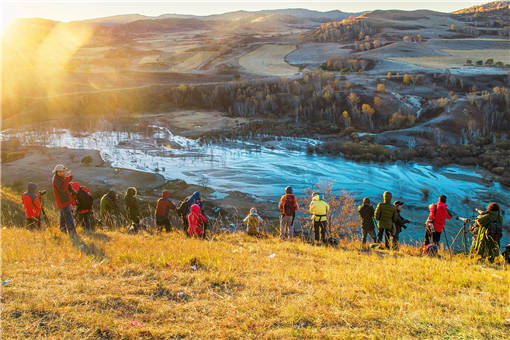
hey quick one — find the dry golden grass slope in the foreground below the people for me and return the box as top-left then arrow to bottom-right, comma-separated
1,224 -> 510,339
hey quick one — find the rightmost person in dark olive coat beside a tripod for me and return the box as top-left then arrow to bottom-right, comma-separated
471,202 -> 503,262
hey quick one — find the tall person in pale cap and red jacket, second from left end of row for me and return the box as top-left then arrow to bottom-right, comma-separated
52,164 -> 76,233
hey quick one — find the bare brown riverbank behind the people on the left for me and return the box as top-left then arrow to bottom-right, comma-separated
1,147 -> 278,225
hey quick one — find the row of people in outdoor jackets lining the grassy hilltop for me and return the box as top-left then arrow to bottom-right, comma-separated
18,164 -> 510,261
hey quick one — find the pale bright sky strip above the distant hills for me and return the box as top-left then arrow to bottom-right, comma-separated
1,0 -> 490,26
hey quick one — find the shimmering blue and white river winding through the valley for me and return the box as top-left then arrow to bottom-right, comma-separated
3,125 -> 510,245
